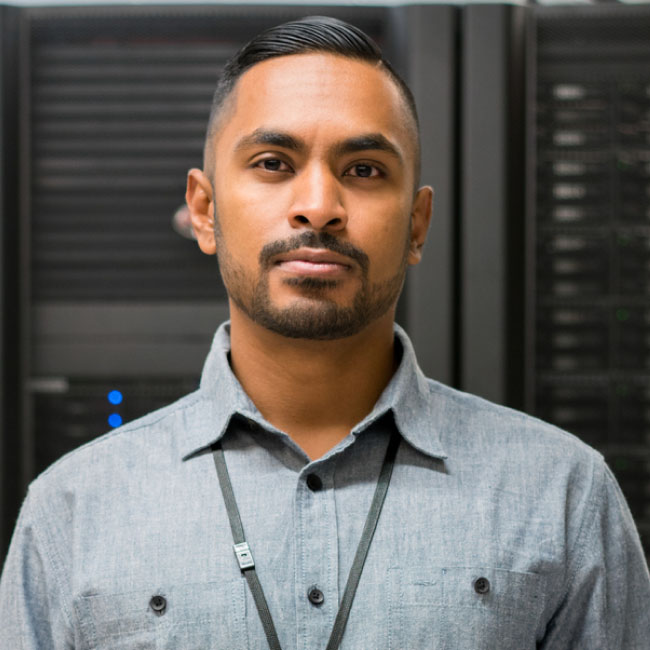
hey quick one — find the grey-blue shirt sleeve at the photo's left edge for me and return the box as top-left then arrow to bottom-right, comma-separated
0,488 -> 74,650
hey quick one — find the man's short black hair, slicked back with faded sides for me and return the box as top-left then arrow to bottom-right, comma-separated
204,16 -> 420,179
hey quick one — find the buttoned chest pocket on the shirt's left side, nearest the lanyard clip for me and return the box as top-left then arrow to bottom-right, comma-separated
75,579 -> 248,650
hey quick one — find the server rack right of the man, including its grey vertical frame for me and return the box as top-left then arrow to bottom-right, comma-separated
448,6 -> 650,552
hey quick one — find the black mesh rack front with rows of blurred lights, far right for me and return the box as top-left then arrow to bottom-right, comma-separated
525,6 -> 650,551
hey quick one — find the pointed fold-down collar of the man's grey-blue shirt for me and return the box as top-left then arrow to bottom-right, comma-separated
181,322 -> 447,458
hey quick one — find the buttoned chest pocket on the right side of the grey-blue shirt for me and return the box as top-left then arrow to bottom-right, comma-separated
389,567 -> 545,650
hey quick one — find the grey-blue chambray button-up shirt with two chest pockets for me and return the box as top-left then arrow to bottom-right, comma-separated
0,324 -> 650,650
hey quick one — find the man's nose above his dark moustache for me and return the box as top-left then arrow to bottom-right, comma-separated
288,165 -> 348,232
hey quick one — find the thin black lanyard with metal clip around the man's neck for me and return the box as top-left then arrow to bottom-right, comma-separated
212,427 -> 400,650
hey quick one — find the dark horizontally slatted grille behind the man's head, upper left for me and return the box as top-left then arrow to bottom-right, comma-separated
31,20 -> 235,301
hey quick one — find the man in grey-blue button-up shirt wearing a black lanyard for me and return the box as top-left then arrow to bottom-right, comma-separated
0,18 -> 650,650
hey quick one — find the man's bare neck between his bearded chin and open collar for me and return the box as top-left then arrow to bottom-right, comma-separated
230,308 -> 395,459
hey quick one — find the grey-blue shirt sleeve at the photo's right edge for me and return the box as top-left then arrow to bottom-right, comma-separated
538,462 -> 650,650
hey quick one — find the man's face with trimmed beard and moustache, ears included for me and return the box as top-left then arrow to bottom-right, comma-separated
188,53 -> 431,339
